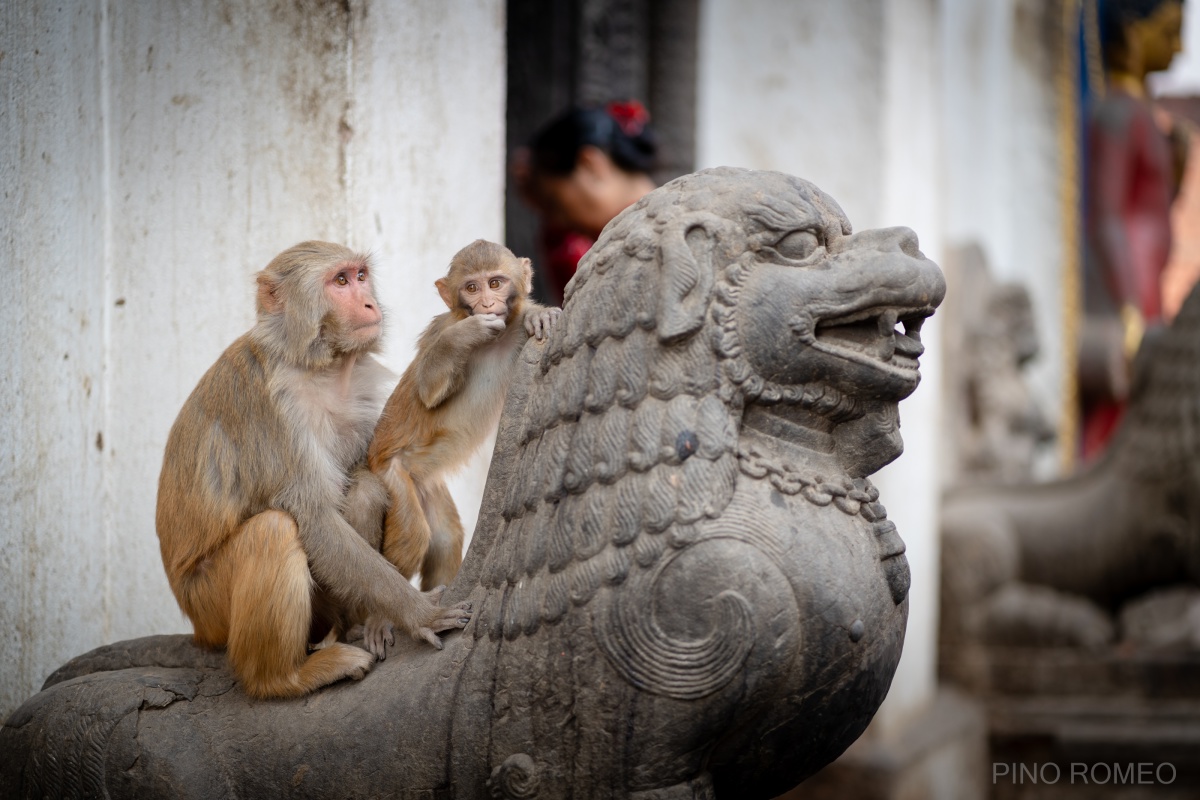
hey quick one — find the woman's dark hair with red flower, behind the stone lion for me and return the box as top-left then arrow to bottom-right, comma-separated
529,100 -> 658,175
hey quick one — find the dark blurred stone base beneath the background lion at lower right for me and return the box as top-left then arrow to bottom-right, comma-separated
943,645 -> 1200,800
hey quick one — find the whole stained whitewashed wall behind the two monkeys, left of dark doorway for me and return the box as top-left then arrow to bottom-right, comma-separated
0,0 -> 505,717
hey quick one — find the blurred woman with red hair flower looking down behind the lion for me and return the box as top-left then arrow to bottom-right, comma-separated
512,100 -> 658,305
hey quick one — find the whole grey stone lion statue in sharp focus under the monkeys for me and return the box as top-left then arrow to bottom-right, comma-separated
0,168 -> 944,799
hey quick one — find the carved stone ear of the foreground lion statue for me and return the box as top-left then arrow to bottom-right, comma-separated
658,222 -> 714,344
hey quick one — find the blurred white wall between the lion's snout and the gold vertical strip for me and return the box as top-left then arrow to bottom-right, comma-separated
940,0 -> 1074,477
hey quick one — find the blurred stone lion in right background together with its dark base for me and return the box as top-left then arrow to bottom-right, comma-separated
940,280 -> 1200,799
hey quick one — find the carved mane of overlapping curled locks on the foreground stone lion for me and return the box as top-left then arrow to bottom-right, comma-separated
475,168 -> 857,639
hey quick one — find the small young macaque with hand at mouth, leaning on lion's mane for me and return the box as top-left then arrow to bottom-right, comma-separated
367,239 -> 560,594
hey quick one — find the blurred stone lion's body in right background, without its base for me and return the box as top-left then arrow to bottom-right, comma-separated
942,280 -> 1200,671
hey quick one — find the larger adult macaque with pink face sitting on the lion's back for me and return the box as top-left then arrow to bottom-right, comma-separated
156,241 -> 469,697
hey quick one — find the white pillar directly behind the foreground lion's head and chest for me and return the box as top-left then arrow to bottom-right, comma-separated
696,0 -> 943,728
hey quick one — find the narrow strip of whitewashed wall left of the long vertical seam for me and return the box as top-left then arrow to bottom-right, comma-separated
0,4 -> 110,716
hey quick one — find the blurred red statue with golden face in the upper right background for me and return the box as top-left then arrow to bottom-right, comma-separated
1079,0 -> 1186,461
